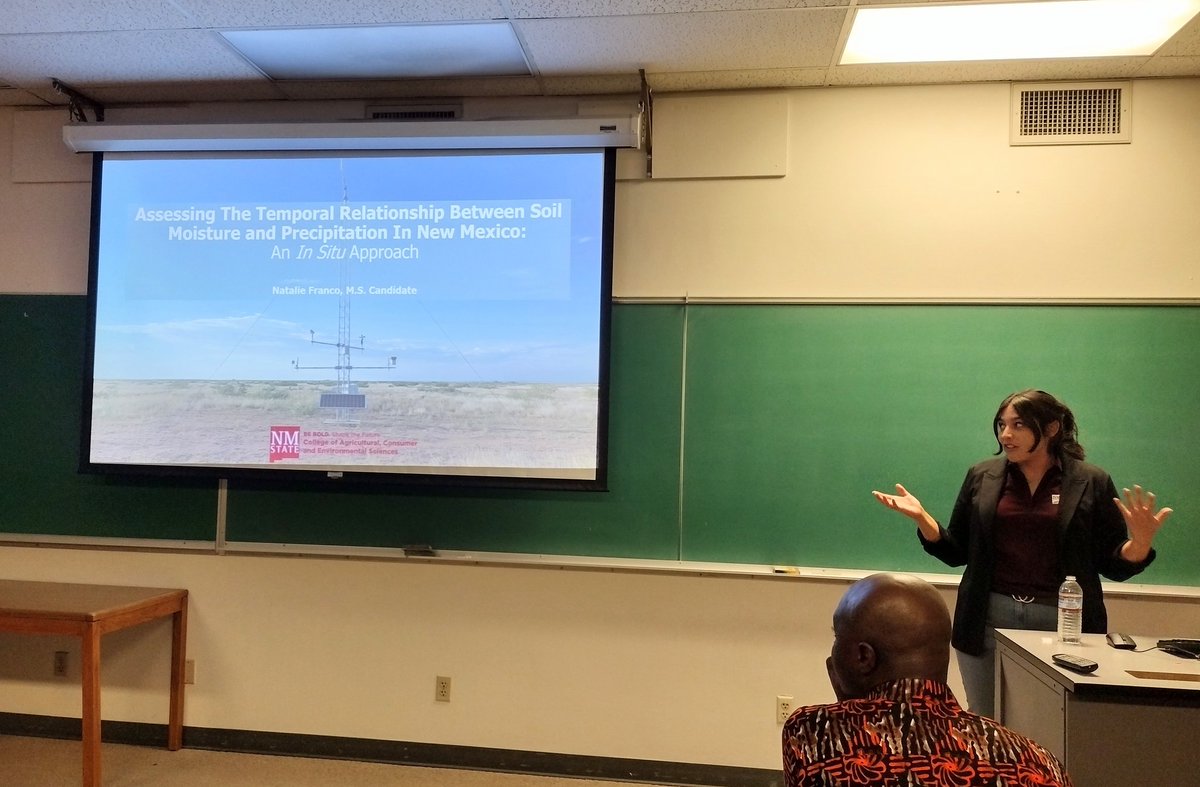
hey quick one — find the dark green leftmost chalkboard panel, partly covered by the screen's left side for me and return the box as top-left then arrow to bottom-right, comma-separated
0,295 -> 217,541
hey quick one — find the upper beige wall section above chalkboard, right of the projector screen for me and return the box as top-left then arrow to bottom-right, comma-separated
613,80 -> 1200,299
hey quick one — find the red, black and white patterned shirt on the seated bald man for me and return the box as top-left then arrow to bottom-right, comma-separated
784,678 -> 1072,787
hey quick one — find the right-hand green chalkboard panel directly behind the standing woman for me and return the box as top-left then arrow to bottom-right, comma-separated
682,305 -> 1200,585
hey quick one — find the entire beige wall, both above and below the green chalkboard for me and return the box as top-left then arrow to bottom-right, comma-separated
0,80 -> 1200,768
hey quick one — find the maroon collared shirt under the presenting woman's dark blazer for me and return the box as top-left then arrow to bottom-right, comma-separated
991,463 -> 1062,599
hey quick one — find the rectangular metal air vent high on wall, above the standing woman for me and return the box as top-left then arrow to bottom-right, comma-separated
1009,82 -> 1133,145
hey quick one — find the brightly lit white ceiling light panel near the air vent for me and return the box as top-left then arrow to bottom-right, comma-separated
839,0 -> 1200,65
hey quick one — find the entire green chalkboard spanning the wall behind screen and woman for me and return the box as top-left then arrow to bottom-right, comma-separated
0,296 -> 1200,587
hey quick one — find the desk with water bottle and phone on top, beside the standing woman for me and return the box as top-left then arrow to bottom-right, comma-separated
996,629 -> 1200,787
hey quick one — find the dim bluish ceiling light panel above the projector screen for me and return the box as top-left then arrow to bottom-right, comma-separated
221,22 -> 529,79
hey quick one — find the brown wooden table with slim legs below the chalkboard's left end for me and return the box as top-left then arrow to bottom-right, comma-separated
0,579 -> 187,787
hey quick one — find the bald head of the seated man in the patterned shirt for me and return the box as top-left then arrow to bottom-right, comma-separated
826,573 -> 950,699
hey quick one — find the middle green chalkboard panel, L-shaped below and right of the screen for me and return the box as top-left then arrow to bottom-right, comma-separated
227,305 -> 683,560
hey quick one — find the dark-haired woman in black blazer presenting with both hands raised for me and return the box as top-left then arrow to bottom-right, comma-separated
872,390 -> 1171,716
